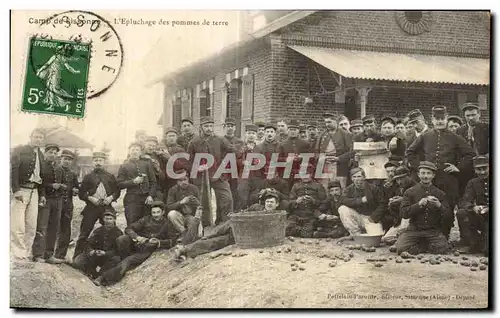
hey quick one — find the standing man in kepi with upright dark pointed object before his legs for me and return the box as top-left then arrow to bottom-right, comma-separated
187,116 -> 238,224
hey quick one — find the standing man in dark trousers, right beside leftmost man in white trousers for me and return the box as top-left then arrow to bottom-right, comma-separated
32,144 -> 63,263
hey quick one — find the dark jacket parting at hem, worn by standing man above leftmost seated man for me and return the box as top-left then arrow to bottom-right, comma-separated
78,170 -> 120,202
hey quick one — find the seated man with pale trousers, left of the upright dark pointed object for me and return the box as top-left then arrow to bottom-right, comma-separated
167,170 -> 200,244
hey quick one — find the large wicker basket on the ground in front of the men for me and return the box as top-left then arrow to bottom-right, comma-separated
230,211 -> 286,248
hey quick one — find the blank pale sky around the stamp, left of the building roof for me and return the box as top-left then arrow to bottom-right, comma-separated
11,10 -> 238,159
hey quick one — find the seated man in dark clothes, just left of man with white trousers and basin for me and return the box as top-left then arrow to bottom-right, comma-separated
313,180 -> 349,238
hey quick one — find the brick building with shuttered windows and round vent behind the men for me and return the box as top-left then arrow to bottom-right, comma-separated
156,11 -> 490,134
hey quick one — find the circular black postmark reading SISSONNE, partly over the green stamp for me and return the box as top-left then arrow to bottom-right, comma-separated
30,11 -> 123,99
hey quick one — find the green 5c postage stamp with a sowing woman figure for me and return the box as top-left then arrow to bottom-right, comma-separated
21,38 -> 91,118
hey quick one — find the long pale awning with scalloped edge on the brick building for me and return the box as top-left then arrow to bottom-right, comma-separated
289,45 -> 490,85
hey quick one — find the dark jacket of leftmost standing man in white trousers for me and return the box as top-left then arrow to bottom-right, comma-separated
10,145 -> 45,196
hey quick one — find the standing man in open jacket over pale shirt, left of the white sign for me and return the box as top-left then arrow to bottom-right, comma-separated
315,113 -> 352,189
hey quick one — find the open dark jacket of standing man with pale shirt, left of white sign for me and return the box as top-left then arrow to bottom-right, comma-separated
315,129 -> 353,177
